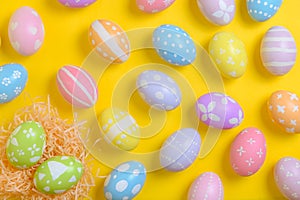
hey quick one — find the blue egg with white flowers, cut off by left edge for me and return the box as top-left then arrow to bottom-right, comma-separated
0,64 -> 28,103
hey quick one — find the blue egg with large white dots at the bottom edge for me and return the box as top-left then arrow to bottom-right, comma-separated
104,161 -> 146,200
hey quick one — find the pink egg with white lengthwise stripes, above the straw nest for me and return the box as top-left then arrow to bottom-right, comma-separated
56,65 -> 98,108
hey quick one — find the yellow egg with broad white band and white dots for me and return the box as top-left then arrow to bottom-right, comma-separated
99,108 -> 140,151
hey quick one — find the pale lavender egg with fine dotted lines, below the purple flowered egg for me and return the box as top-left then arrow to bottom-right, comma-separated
160,128 -> 201,172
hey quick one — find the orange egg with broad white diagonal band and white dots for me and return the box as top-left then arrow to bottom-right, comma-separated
89,19 -> 130,63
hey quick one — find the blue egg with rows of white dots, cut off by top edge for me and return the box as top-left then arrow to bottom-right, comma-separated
247,0 -> 282,22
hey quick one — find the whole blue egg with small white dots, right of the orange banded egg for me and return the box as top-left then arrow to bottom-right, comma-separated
152,24 -> 196,66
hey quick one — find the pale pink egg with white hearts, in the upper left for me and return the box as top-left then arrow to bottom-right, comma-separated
8,6 -> 45,56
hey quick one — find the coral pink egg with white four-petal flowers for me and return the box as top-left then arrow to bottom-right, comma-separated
230,128 -> 266,176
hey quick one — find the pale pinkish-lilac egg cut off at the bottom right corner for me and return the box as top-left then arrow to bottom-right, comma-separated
274,157 -> 300,200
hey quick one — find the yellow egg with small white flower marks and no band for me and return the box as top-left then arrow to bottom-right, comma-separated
209,32 -> 248,78
